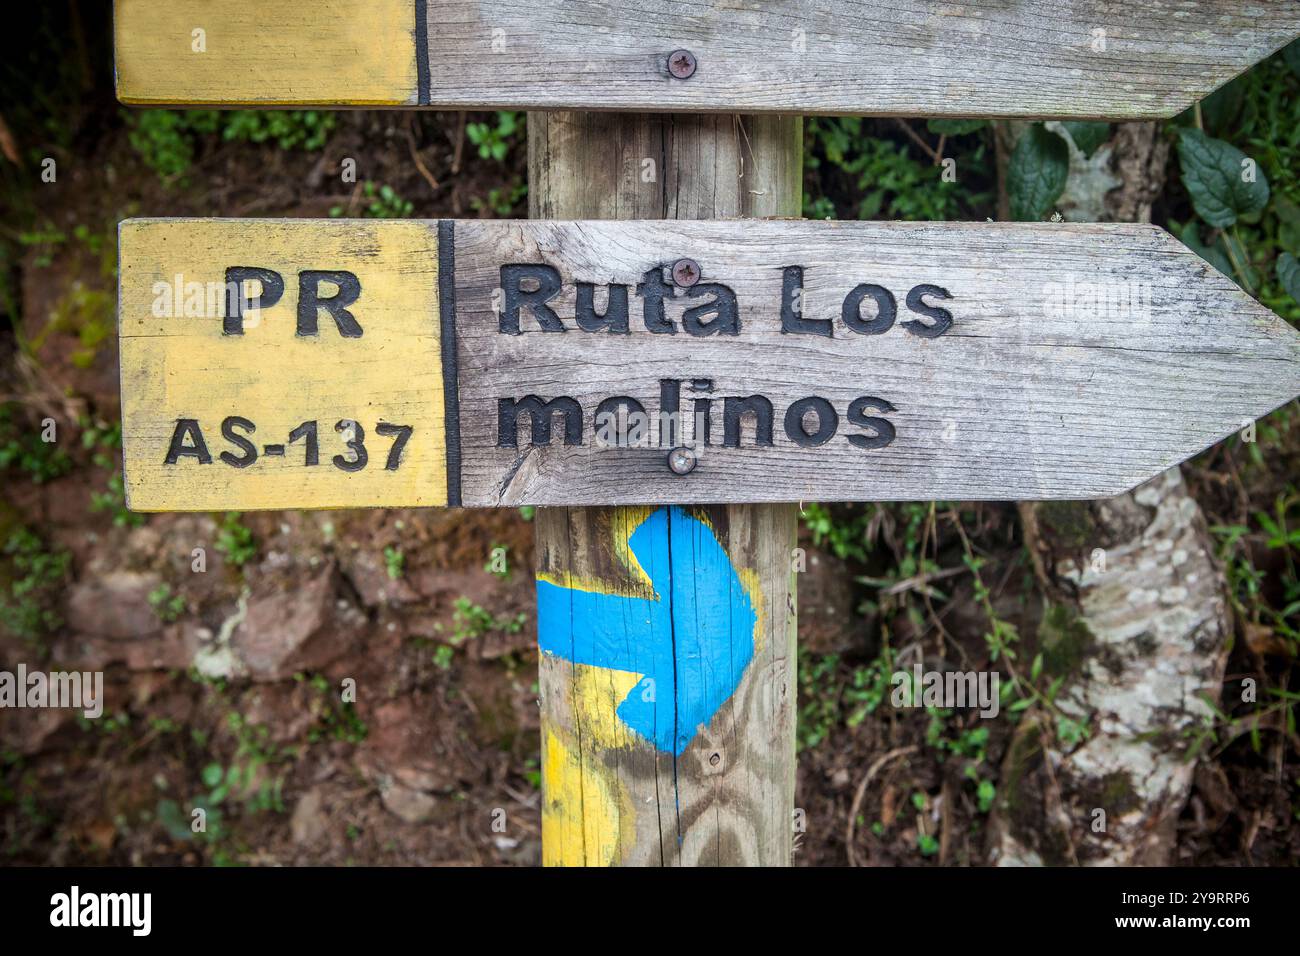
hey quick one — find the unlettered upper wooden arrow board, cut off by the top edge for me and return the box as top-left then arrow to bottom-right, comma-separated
116,0 -> 1300,120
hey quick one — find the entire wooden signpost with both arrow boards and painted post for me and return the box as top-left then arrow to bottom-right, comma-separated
116,0 -> 1300,865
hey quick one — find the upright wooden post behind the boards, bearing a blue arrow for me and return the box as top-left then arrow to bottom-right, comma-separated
528,112 -> 803,866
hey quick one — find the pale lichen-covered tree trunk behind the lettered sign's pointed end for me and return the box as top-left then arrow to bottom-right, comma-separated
991,124 -> 1230,866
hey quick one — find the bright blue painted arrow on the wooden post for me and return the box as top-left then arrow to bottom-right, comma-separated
537,507 -> 758,754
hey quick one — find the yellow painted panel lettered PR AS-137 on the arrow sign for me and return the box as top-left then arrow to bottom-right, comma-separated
118,220 -> 447,511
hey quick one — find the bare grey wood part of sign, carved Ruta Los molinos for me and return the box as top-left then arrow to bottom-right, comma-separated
456,214 -> 1300,505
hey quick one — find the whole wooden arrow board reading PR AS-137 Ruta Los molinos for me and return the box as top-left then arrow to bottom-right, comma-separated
120,220 -> 1300,511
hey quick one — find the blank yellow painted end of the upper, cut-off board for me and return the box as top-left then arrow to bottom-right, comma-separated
113,0 -> 417,107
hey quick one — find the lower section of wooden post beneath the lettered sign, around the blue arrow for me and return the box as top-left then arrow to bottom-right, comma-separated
537,505 -> 797,866
